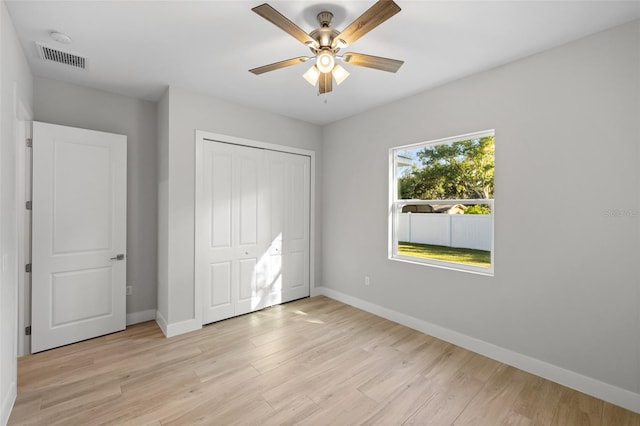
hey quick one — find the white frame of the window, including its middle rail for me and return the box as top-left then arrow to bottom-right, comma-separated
388,129 -> 495,276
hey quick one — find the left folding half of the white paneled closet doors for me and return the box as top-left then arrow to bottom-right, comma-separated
202,142 -> 267,324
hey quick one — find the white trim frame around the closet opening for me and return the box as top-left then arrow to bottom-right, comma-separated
193,130 -> 319,325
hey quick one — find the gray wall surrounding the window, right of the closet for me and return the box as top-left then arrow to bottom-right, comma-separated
322,21 -> 640,394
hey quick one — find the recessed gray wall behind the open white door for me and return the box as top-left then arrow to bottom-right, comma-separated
34,78 -> 158,319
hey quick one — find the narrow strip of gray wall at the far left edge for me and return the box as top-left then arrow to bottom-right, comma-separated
0,0 -> 33,424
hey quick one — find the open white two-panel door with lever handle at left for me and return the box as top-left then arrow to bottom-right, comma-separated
31,122 -> 127,352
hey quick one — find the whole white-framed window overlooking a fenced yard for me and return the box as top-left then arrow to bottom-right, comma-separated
389,130 -> 495,275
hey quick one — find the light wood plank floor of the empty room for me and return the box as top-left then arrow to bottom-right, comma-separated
9,297 -> 640,426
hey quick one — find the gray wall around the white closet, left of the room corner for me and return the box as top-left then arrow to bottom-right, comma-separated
158,87 -> 322,324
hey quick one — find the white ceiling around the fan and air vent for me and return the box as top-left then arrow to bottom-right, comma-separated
6,0 -> 640,124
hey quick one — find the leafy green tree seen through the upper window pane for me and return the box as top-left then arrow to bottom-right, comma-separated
398,136 -> 495,200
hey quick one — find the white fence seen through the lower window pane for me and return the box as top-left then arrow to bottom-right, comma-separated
396,213 -> 492,250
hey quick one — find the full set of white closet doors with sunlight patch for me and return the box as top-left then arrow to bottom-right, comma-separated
196,141 -> 310,324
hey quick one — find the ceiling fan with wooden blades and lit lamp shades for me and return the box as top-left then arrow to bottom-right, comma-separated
249,0 -> 404,94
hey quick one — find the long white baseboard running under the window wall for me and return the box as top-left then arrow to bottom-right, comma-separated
314,287 -> 640,413
